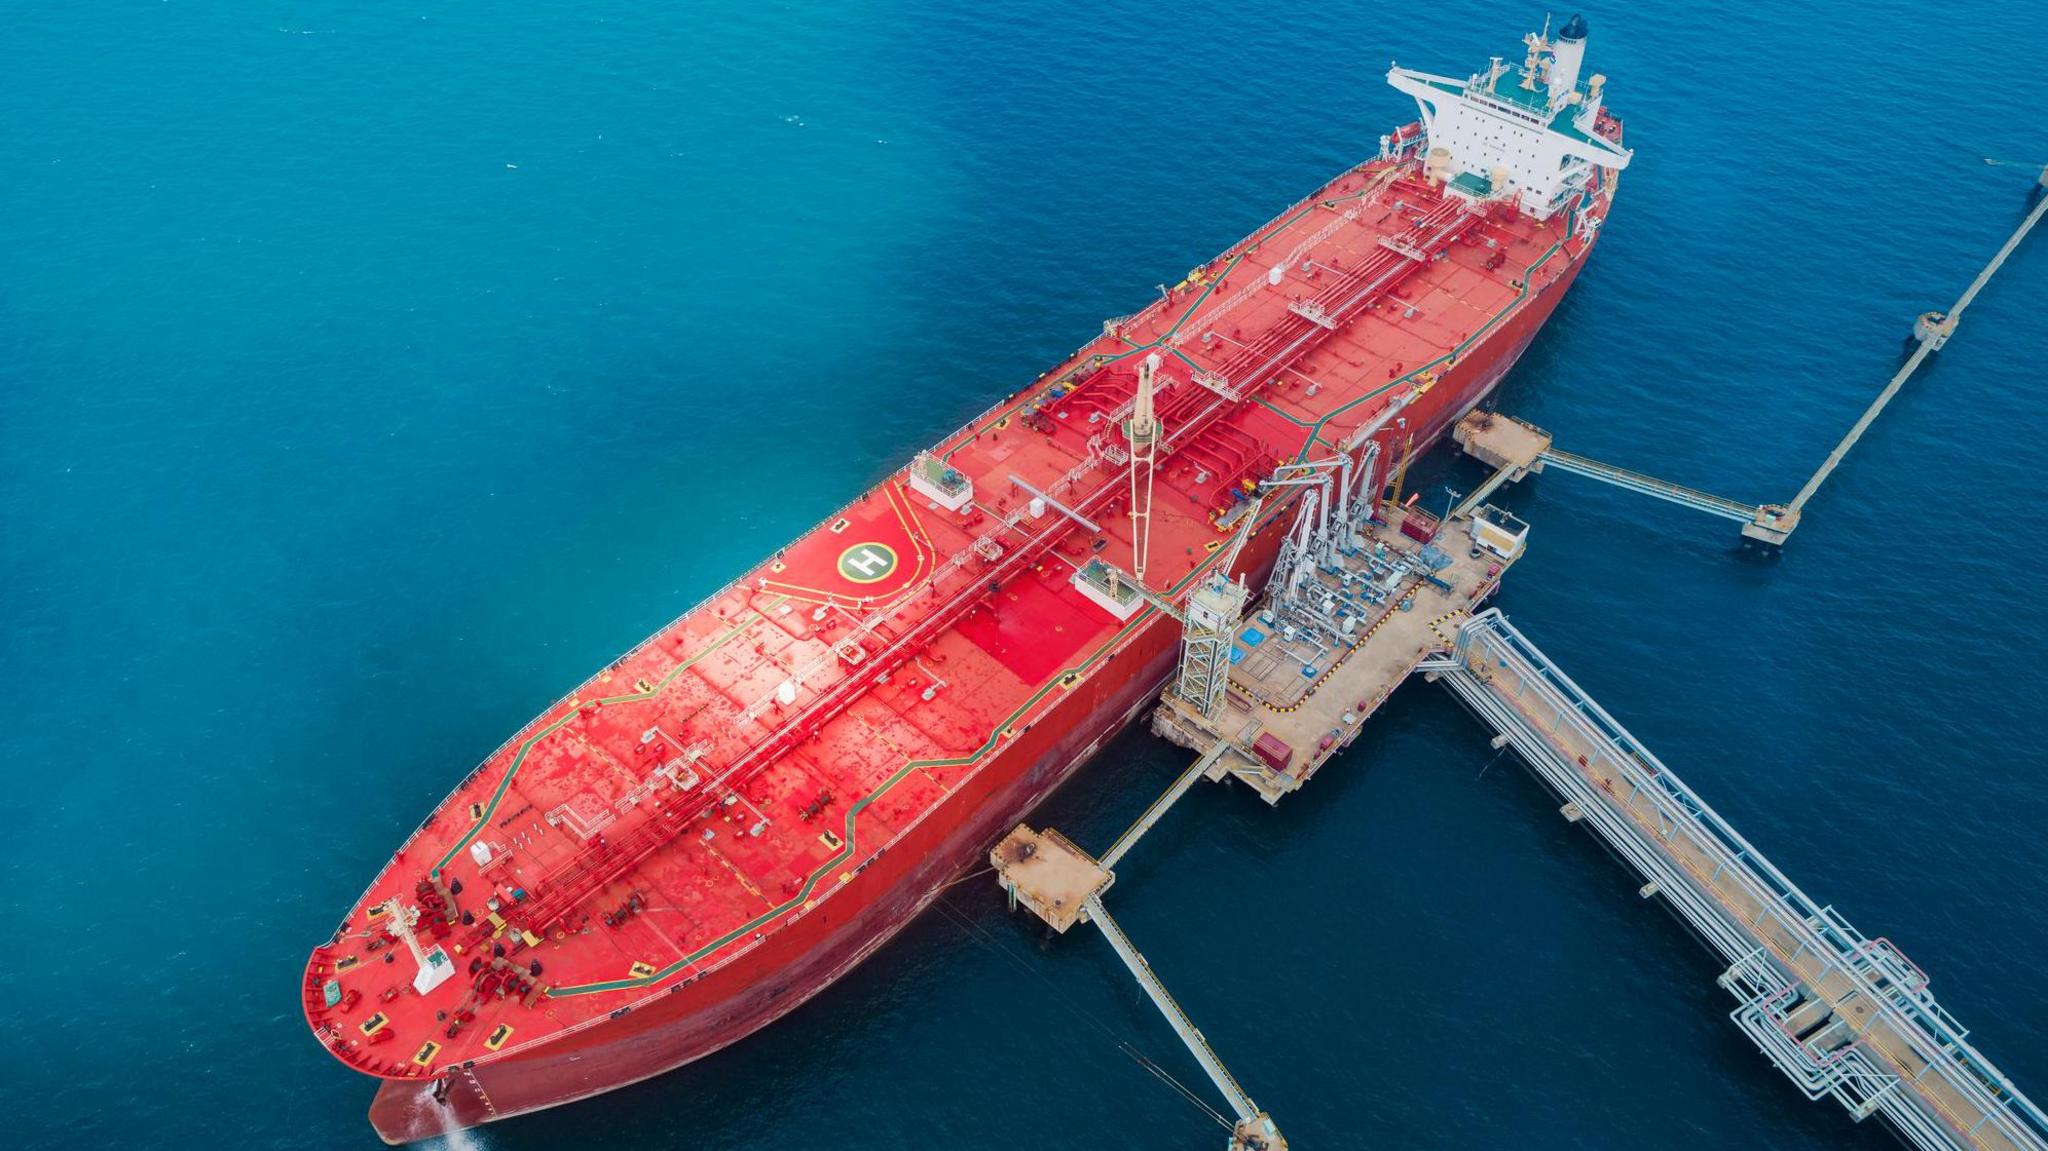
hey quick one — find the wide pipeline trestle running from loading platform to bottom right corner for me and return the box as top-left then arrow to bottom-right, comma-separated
1417,608 -> 2048,1151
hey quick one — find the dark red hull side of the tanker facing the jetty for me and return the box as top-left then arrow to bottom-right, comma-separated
371,237 -> 1591,1143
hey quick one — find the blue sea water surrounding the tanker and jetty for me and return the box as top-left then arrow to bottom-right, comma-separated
0,0 -> 2048,1151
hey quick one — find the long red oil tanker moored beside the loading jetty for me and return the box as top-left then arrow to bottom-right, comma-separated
303,16 -> 1630,1143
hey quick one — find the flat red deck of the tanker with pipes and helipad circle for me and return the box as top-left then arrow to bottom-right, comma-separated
305,127 -> 1608,1116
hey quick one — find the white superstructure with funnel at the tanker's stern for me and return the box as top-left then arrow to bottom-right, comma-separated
1380,16 -> 1632,217
